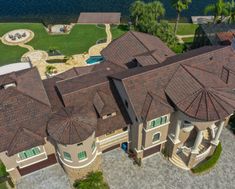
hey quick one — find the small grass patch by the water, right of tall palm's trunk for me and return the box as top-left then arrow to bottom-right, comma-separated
170,23 -> 199,35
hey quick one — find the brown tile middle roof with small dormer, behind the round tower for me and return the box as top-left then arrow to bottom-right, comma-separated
44,61 -> 130,142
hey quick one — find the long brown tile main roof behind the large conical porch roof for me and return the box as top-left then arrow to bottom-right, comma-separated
112,47 -> 234,119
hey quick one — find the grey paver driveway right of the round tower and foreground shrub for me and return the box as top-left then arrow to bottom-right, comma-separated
102,129 -> 235,189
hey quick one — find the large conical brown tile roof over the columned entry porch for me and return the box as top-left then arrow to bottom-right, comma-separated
165,65 -> 235,121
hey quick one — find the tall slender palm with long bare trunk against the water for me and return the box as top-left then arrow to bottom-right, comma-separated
171,0 -> 192,35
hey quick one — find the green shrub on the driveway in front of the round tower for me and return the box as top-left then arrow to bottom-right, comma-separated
73,171 -> 109,189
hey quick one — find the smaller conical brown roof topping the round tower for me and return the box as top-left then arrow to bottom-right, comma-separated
47,106 -> 97,144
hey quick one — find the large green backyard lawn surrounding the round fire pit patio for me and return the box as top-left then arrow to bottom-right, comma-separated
0,23 -> 106,64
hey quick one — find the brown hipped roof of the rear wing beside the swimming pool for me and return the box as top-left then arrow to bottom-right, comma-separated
101,31 -> 175,67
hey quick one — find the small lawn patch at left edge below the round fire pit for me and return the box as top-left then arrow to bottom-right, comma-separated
0,42 -> 28,66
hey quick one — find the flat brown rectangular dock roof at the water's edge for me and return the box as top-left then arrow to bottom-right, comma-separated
78,12 -> 121,24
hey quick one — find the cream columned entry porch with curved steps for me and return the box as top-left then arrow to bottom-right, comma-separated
170,121 -> 224,170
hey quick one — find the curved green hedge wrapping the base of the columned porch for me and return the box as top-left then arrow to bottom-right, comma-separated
191,143 -> 222,173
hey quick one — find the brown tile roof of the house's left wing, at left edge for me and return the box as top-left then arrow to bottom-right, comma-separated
0,68 -> 50,155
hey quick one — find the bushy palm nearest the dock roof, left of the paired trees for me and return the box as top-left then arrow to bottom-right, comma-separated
130,0 -> 145,27
